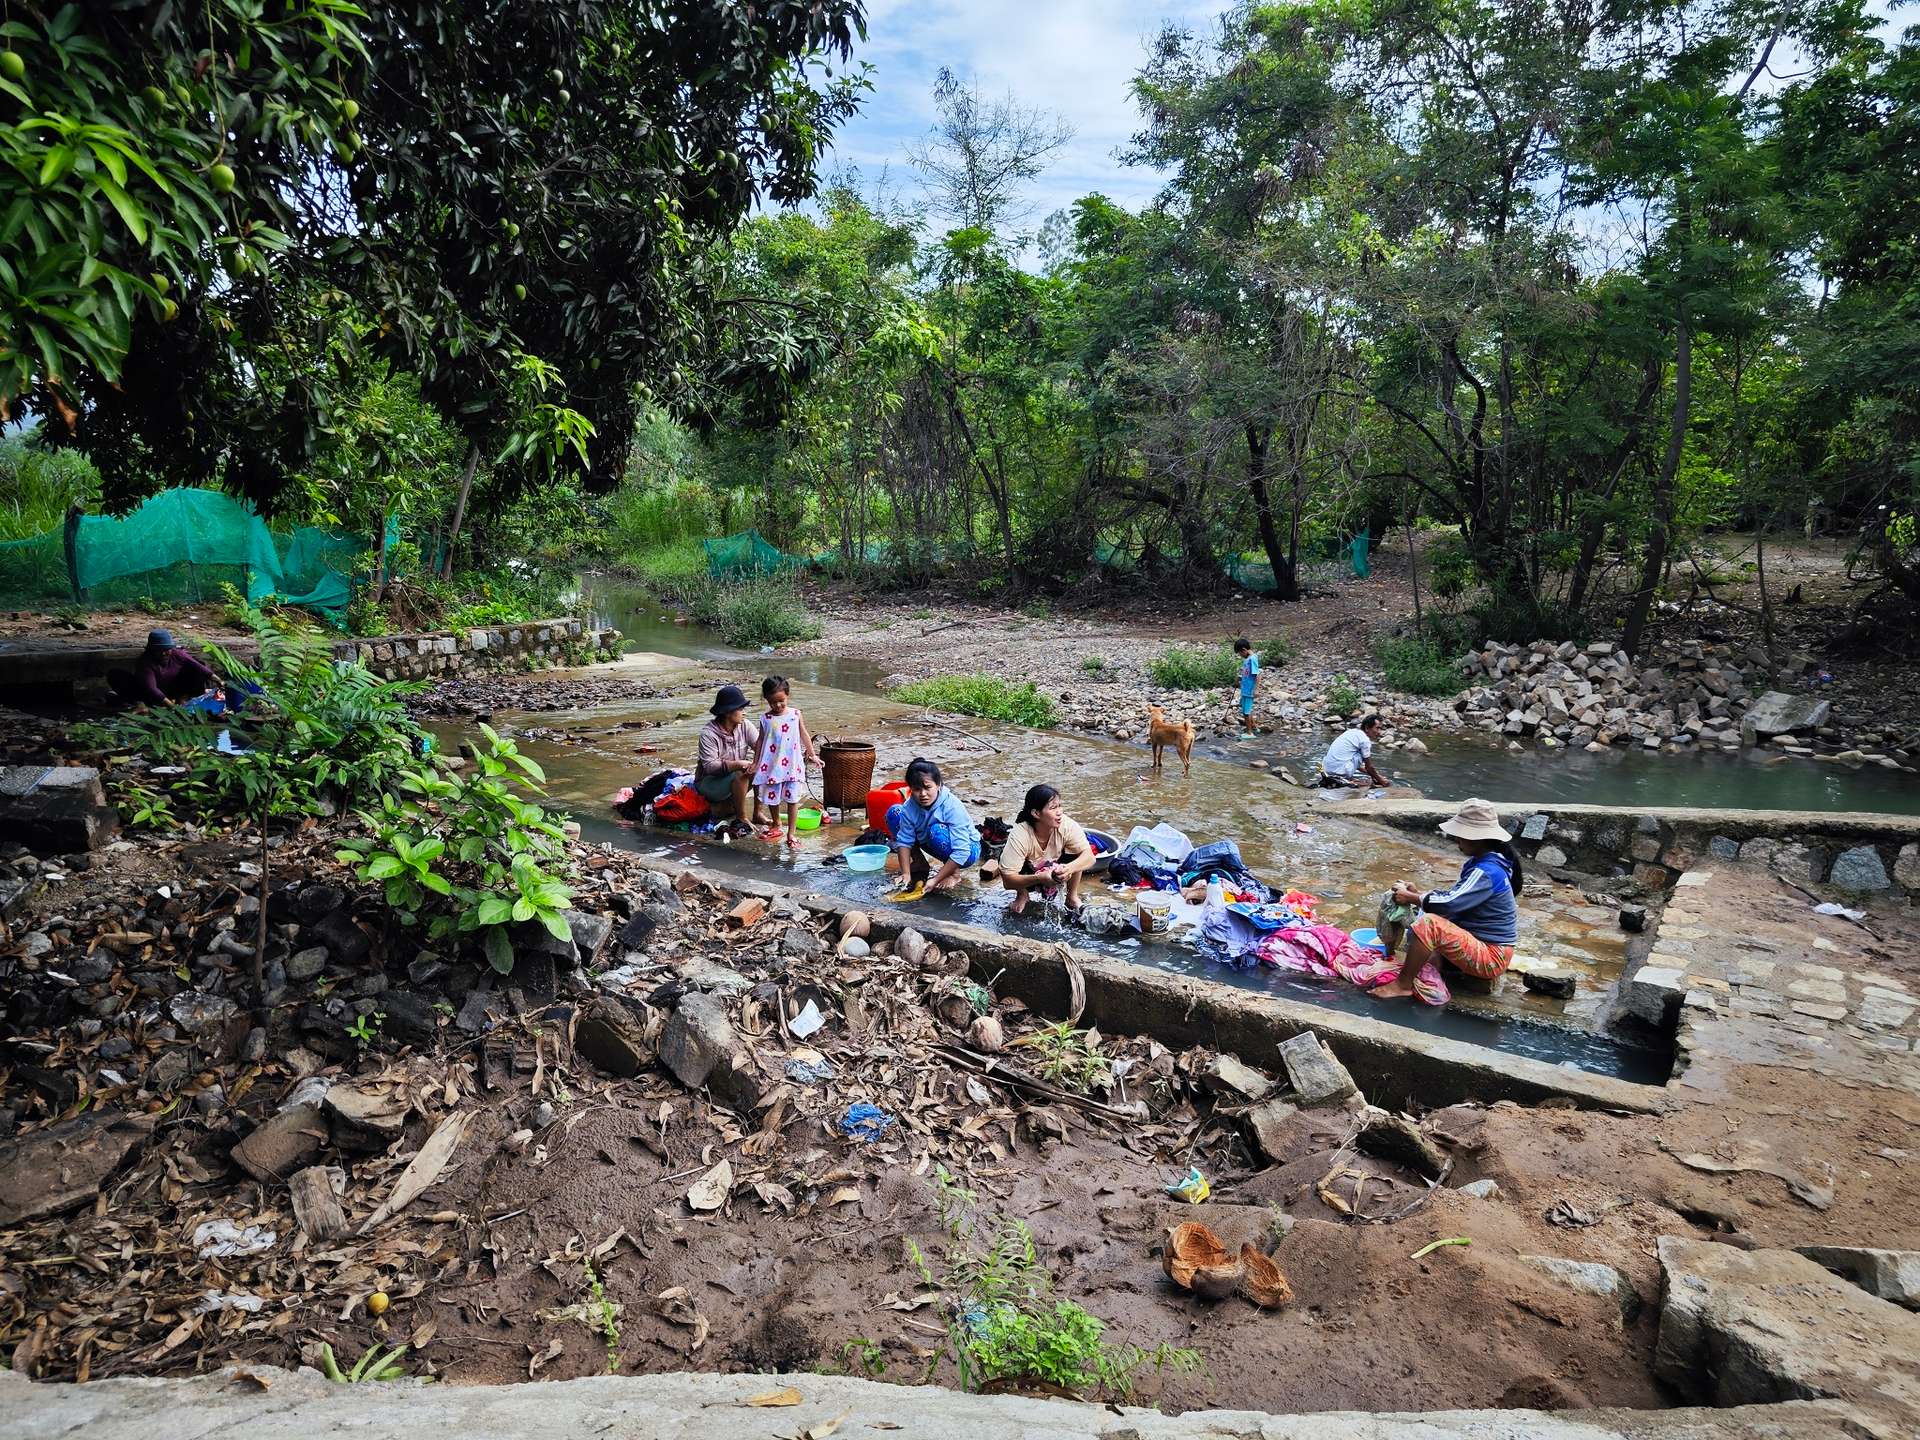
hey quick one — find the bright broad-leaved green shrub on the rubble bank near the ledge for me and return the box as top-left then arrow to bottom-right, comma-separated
338,724 -> 572,973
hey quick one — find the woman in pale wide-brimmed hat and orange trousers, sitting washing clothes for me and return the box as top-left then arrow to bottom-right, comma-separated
1373,801 -> 1526,1000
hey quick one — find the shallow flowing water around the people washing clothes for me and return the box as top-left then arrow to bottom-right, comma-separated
432,618 -> 1668,1083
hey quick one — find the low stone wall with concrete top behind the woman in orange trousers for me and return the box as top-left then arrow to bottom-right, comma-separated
1348,801 -> 1920,899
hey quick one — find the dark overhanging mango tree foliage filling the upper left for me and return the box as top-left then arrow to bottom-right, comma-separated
0,0 -> 864,503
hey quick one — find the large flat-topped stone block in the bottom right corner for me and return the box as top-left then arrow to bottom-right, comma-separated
1653,1235 -> 1920,1411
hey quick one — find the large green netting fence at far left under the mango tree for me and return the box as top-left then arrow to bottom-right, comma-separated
0,490 -> 369,624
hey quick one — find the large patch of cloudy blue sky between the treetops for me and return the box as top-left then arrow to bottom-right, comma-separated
817,0 -> 1227,240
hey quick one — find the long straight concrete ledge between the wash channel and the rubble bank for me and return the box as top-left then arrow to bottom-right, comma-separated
641,858 -> 1667,1114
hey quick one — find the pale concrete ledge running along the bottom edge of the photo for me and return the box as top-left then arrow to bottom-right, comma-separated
0,1365 -> 1882,1440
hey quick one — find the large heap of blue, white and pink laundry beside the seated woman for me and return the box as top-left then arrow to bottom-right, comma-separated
1108,824 -> 1452,1004
